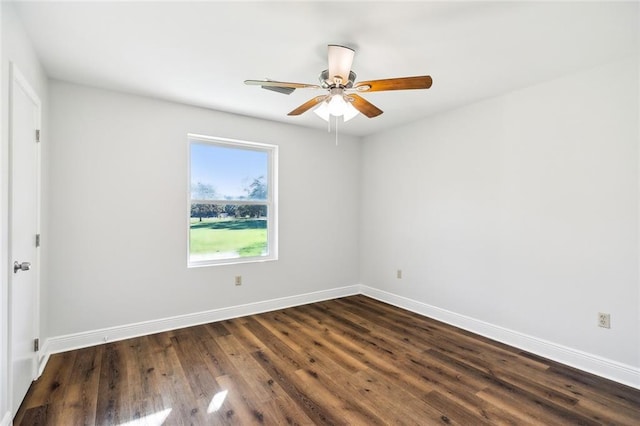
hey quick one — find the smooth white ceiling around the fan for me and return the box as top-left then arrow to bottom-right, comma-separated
15,1 -> 639,136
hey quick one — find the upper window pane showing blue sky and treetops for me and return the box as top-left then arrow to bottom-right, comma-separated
191,143 -> 269,201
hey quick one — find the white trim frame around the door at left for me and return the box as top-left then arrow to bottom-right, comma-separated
7,62 -> 42,416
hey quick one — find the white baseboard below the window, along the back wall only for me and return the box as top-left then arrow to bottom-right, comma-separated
39,285 -> 361,362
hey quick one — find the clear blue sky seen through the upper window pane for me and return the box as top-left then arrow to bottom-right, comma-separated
191,143 -> 269,200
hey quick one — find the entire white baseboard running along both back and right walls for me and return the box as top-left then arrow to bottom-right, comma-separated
40,284 -> 640,392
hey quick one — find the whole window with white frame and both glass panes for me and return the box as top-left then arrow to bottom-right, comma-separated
188,134 -> 277,266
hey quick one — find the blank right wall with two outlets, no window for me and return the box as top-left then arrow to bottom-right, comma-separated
361,57 -> 640,380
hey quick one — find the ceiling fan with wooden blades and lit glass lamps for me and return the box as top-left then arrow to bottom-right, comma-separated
244,44 -> 432,121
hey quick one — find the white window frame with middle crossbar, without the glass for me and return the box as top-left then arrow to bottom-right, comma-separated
186,133 -> 278,268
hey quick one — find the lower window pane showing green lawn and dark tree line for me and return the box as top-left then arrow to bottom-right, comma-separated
189,203 -> 269,262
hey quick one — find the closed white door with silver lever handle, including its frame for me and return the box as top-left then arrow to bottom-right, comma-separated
9,64 -> 40,415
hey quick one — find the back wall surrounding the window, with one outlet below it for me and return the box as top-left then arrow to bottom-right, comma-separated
45,81 -> 360,336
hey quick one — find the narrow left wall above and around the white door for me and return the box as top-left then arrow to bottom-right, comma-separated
0,2 -> 48,422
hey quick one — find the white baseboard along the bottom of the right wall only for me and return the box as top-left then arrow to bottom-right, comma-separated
361,286 -> 640,389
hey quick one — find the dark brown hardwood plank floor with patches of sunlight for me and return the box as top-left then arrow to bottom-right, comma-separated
15,296 -> 640,426
